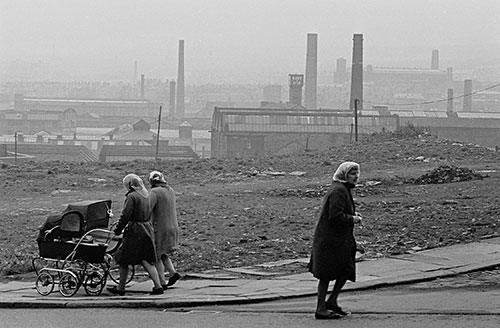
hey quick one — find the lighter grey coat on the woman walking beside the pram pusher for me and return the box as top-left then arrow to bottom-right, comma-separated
149,184 -> 179,258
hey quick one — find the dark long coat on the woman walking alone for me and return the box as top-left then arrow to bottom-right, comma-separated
309,182 -> 356,281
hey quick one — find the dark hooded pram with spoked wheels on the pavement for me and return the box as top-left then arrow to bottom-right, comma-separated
32,200 -> 117,297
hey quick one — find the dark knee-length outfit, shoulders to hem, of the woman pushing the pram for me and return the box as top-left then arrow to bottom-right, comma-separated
115,191 -> 156,265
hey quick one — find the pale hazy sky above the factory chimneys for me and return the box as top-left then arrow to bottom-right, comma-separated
0,0 -> 500,82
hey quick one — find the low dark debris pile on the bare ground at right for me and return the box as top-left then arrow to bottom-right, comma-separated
414,165 -> 484,185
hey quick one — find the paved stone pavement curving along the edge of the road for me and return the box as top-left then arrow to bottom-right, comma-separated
0,237 -> 500,308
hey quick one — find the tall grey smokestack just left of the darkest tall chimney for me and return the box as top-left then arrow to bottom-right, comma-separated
304,33 -> 318,109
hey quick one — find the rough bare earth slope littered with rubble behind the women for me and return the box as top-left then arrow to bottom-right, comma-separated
0,135 -> 500,277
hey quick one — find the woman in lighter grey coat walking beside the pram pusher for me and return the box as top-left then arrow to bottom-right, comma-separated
148,171 -> 181,289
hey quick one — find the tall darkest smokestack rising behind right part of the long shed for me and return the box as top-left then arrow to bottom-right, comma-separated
349,34 -> 363,111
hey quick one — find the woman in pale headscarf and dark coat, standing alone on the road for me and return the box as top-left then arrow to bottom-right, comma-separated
309,162 -> 362,319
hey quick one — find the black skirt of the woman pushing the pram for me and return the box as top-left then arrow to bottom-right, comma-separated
115,221 -> 156,265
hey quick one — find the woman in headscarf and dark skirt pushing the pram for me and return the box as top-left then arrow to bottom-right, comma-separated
108,174 -> 163,295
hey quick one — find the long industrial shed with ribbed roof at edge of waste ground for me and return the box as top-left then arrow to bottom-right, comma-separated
211,107 -> 399,158
